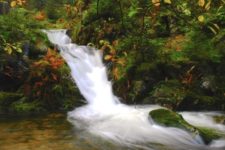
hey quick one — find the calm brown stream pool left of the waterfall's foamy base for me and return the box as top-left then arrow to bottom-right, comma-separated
0,114 -> 127,150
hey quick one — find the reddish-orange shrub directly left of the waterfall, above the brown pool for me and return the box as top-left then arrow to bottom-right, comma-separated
24,49 -> 79,110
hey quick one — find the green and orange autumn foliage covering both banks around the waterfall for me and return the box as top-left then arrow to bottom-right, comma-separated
0,0 -> 225,110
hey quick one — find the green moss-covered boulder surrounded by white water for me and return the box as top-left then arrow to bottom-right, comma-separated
149,109 -> 223,144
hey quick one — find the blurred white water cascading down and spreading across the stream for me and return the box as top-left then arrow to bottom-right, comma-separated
44,30 -> 225,150
